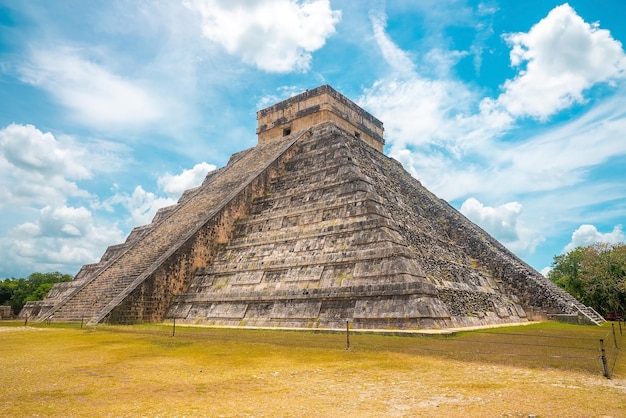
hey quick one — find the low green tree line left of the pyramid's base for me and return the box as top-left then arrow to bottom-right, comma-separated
0,271 -> 72,315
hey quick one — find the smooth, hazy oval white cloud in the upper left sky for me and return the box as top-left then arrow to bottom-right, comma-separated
19,47 -> 165,129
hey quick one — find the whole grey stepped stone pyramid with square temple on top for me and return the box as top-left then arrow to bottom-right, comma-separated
22,85 -> 602,329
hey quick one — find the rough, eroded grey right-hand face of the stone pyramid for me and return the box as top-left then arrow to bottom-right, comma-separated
352,137 -> 578,314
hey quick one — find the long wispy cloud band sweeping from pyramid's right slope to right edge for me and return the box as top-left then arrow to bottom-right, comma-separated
387,83 -> 626,205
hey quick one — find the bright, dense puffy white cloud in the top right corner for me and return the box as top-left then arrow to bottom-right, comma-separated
498,4 -> 626,120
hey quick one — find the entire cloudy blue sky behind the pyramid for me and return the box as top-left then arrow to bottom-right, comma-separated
0,0 -> 626,278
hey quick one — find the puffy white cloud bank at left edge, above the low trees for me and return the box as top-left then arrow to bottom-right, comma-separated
0,124 -> 133,275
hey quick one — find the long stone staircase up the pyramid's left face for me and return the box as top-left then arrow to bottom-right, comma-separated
31,132 -> 306,324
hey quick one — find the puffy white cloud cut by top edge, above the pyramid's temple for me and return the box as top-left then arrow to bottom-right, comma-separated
186,0 -> 341,73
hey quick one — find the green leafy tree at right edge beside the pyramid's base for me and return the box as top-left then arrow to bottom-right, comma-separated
548,243 -> 626,316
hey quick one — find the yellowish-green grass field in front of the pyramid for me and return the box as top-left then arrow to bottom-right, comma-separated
0,322 -> 626,417
